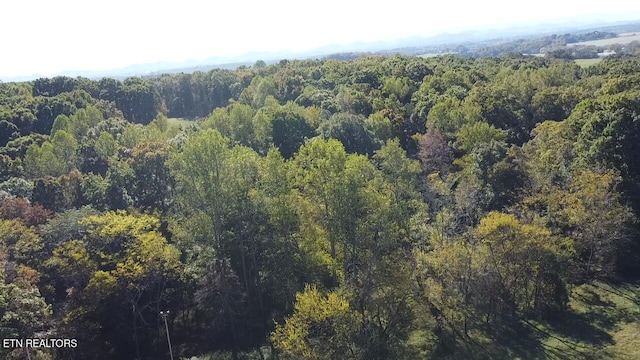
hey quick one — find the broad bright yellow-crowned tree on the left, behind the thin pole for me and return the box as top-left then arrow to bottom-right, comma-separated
46,211 -> 182,357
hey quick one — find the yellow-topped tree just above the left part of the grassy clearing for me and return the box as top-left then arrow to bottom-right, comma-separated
476,212 -> 573,314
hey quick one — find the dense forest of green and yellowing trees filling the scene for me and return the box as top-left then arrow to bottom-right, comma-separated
0,55 -> 640,360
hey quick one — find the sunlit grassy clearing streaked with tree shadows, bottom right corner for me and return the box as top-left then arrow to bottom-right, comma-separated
451,282 -> 640,360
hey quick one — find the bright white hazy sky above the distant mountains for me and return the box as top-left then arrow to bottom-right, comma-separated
0,0 -> 640,77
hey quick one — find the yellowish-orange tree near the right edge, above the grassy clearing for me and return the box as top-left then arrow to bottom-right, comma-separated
523,170 -> 634,282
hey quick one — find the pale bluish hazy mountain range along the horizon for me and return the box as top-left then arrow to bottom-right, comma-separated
5,15 -> 640,82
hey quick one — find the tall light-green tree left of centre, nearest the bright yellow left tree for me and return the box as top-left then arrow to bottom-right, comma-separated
168,129 -> 275,351
